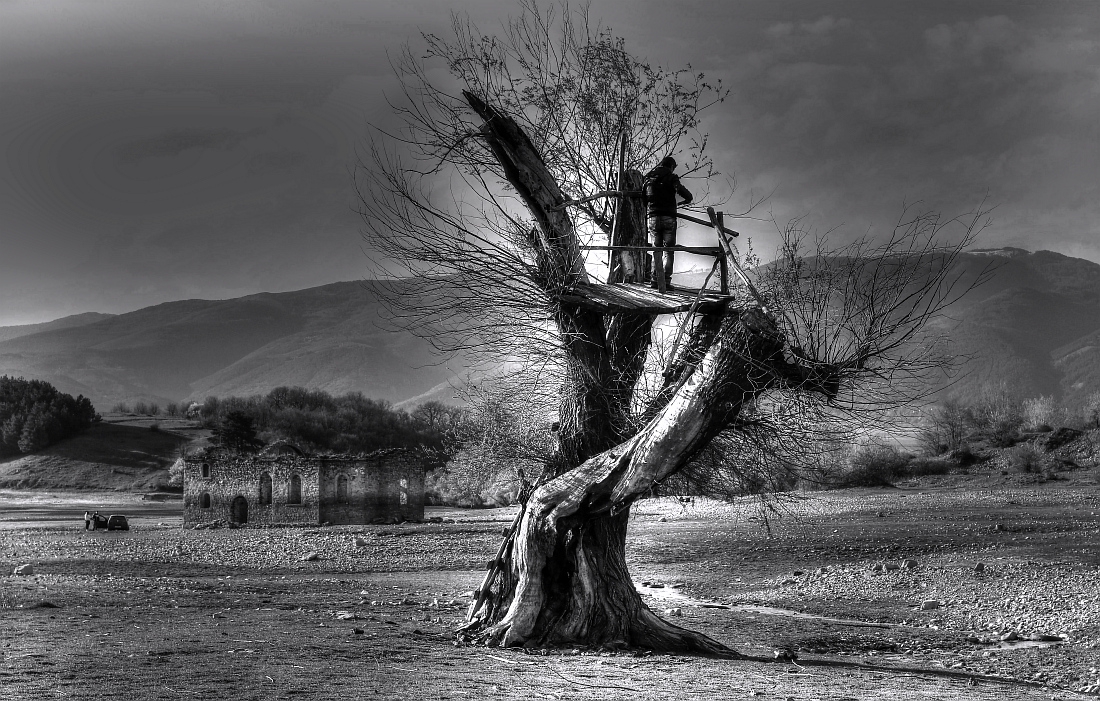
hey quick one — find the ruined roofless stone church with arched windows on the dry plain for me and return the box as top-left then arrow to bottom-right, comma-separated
184,443 -> 425,527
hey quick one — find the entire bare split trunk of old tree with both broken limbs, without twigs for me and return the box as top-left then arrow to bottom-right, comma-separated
460,92 -> 818,655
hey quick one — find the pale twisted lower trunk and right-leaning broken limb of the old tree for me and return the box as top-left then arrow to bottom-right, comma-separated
468,309 -> 782,654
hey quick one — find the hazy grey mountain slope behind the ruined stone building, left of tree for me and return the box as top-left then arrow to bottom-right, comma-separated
0,282 -> 461,410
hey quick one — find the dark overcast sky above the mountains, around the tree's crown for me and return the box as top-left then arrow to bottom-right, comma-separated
0,0 -> 1100,326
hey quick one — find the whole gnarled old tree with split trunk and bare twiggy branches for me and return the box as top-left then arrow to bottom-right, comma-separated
358,7 -> 990,654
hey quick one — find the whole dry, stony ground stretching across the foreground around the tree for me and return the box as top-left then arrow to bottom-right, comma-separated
0,473 -> 1100,701
